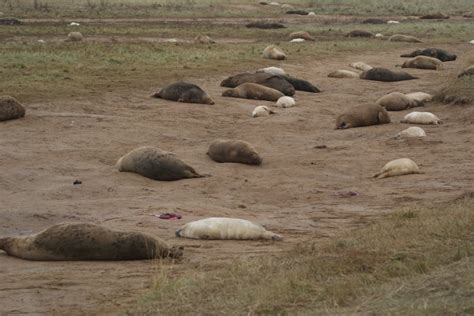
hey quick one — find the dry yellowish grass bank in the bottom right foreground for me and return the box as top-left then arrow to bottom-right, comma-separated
129,195 -> 474,315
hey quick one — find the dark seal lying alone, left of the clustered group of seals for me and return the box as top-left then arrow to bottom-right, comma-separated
153,82 -> 214,105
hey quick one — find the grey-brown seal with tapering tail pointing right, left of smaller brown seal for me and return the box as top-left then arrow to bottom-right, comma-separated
117,146 -> 204,181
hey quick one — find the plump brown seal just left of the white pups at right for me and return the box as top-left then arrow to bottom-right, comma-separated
336,104 -> 390,129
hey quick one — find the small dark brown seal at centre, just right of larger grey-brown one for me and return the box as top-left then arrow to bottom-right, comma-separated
207,139 -> 263,165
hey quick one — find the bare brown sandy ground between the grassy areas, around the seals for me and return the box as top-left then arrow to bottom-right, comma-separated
0,37 -> 474,315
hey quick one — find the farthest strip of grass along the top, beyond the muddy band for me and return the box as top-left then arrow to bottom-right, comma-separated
0,0 -> 472,18
